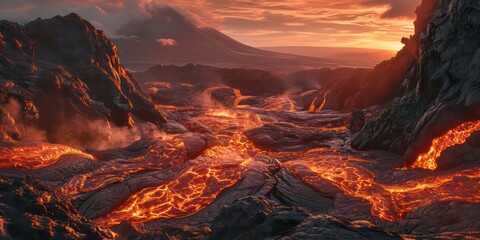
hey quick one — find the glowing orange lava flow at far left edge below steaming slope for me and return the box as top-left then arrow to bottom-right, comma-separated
0,143 -> 94,170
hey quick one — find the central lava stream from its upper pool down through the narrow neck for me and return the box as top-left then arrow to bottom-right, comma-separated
95,110 -> 259,226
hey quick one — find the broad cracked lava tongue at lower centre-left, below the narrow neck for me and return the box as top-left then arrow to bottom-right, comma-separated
94,147 -> 251,227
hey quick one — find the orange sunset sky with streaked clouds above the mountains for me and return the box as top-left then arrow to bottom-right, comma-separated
0,0 -> 421,50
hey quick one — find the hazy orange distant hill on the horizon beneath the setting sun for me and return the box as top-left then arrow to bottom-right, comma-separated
260,46 -> 396,67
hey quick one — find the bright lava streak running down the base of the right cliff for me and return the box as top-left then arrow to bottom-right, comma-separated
412,121 -> 480,170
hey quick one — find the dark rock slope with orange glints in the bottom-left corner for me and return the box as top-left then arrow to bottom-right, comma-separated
0,179 -> 113,239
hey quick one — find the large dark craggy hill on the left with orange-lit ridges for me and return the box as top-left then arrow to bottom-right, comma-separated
0,14 -> 166,146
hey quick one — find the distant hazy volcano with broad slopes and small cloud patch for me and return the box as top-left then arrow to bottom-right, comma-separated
113,6 -> 349,72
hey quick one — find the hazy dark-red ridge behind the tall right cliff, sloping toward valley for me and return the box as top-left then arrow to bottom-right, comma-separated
286,32 -> 418,111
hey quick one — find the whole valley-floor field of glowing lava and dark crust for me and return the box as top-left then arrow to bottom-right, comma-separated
0,104 -> 480,238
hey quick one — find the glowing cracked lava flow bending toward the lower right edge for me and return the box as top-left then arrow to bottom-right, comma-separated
284,150 -> 480,221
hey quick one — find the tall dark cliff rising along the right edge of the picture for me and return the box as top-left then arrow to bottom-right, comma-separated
352,0 -> 480,164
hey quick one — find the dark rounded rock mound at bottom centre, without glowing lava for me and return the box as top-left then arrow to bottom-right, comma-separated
210,197 -> 402,239
